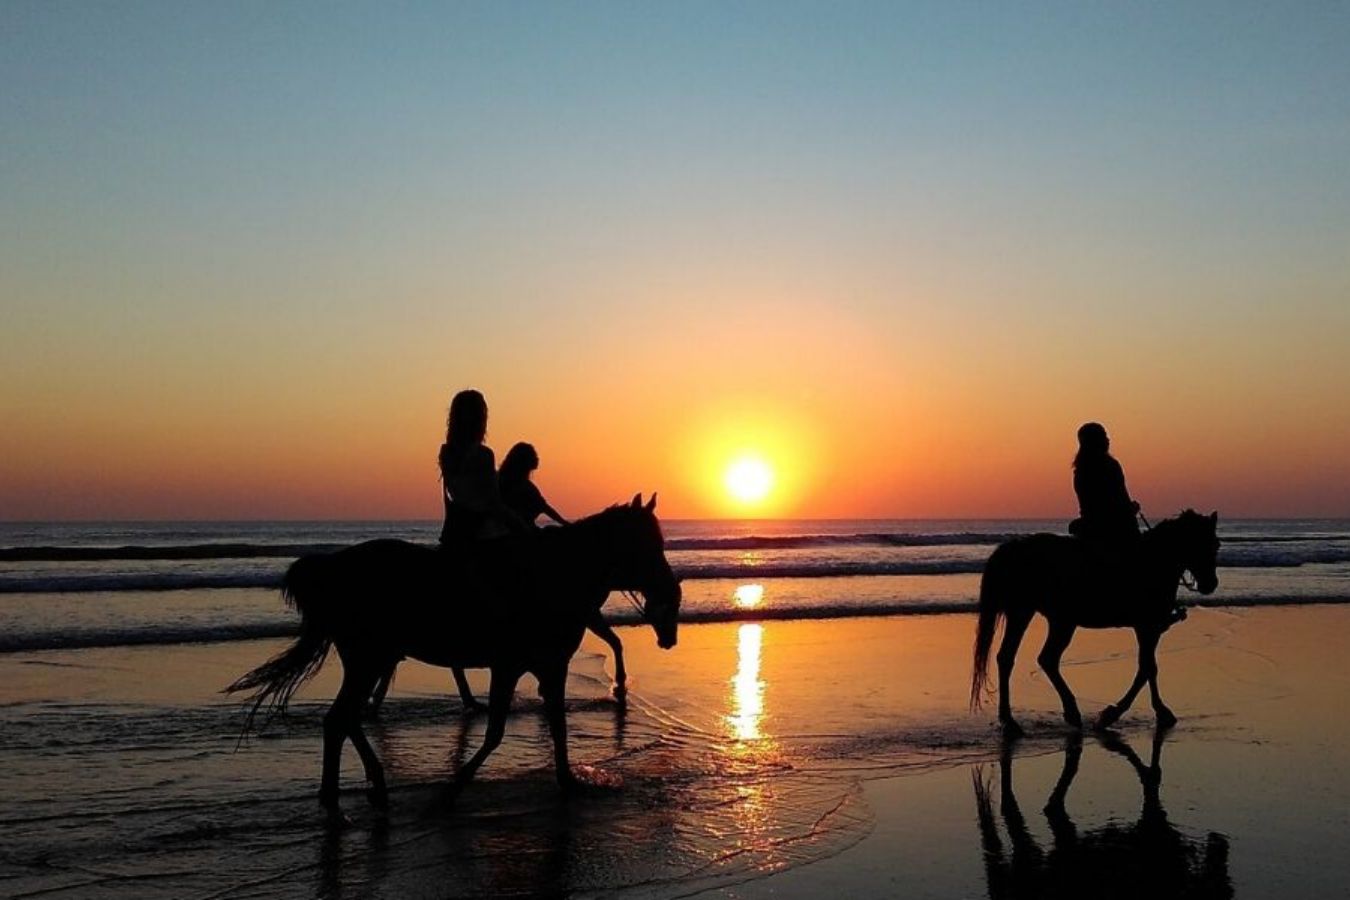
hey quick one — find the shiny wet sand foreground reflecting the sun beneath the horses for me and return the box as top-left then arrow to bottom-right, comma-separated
0,606 -> 1350,897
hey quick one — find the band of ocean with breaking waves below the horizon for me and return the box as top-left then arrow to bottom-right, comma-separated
0,519 -> 1350,652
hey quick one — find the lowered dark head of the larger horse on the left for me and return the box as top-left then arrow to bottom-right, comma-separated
605,494 -> 680,650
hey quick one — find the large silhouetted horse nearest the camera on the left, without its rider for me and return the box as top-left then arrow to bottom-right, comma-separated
225,495 -> 680,815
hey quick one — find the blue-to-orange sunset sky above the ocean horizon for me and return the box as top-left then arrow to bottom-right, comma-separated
0,0 -> 1350,519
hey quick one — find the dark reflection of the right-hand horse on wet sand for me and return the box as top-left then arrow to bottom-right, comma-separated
972,729 -> 1233,900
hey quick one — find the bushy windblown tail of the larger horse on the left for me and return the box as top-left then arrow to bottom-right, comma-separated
225,556 -> 332,734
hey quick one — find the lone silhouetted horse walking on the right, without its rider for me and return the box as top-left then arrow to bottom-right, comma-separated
971,510 -> 1219,735
